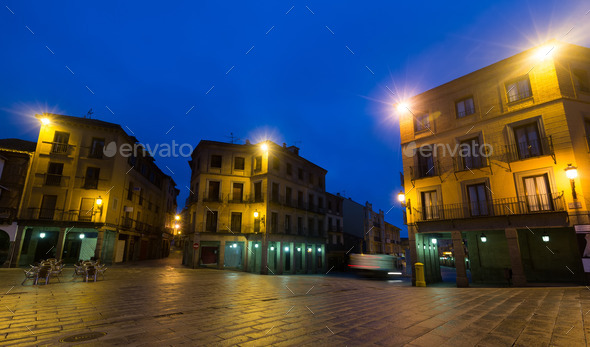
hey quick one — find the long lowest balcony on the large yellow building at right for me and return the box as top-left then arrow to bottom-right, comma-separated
416,193 -> 565,222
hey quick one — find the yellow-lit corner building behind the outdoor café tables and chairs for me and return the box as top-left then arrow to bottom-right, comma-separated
13,114 -> 178,266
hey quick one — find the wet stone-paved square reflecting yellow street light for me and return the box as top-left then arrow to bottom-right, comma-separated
0,251 -> 590,346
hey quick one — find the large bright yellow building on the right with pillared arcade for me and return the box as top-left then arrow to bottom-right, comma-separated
397,42 -> 590,287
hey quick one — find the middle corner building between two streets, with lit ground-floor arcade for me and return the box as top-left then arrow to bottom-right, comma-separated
184,140 -> 328,274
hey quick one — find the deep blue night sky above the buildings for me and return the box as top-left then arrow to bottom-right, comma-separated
0,0 -> 590,237
